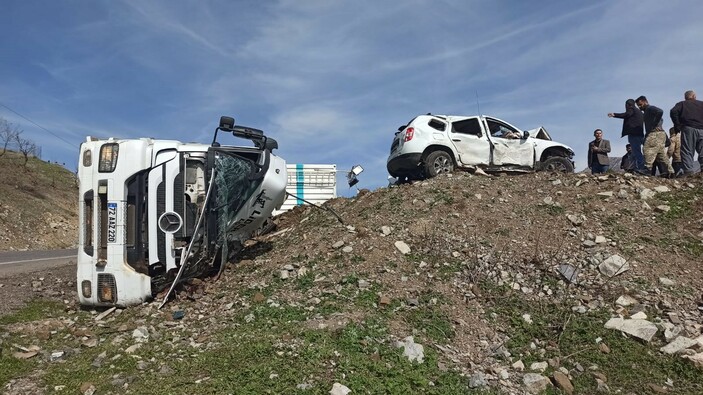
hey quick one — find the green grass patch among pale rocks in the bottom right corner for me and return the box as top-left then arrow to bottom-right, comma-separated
484,287 -> 703,394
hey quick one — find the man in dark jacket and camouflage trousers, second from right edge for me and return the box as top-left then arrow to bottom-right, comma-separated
635,96 -> 674,177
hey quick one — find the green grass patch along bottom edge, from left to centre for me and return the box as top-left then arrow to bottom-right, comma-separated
38,307 -> 476,394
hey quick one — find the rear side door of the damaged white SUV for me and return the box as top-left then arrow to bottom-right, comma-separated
449,117 -> 491,166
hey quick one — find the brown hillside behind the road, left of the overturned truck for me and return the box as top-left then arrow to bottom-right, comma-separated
0,151 -> 78,251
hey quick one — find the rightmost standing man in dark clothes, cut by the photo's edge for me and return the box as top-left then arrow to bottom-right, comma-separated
669,91 -> 703,174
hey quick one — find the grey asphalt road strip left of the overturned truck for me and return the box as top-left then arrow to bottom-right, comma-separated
0,249 -> 77,278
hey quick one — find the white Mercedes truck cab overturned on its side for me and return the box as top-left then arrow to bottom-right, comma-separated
77,117 -> 287,306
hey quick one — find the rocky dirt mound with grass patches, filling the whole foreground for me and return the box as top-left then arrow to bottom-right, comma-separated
0,173 -> 703,394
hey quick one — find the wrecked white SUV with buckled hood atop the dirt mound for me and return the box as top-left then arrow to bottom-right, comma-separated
386,114 -> 574,180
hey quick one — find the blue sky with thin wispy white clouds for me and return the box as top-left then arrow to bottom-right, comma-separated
0,0 -> 703,195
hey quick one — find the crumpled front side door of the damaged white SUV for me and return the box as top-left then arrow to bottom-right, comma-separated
485,117 -> 535,168
